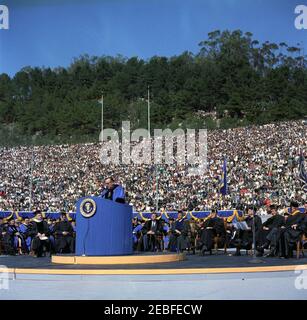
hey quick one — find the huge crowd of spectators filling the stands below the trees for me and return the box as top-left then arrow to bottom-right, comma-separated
0,121 -> 307,212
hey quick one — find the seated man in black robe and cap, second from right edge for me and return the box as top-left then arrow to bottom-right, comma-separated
257,204 -> 285,257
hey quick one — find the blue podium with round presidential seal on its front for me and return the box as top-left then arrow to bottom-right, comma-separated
76,197 -> 133,256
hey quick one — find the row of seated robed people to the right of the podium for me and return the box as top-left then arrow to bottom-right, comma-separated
133,201 -> 307,258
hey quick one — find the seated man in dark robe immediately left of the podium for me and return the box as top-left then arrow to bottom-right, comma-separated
53,212 -> 75,253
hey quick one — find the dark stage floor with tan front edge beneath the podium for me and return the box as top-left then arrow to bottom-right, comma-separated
0,253 -> 307,275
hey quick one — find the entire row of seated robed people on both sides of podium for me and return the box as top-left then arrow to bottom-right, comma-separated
0,202 -> 307,258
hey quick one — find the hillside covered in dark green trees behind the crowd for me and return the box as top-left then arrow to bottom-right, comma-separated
0,30 -> 307,145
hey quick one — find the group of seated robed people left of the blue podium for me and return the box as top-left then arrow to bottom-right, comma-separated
0,210 -> 75,257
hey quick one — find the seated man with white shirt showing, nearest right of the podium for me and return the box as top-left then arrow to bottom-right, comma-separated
142,213 -> 163,251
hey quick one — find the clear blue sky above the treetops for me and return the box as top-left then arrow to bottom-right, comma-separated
0,0 -> 307,76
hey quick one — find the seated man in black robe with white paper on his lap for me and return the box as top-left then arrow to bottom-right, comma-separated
29,210 -> 50,257
